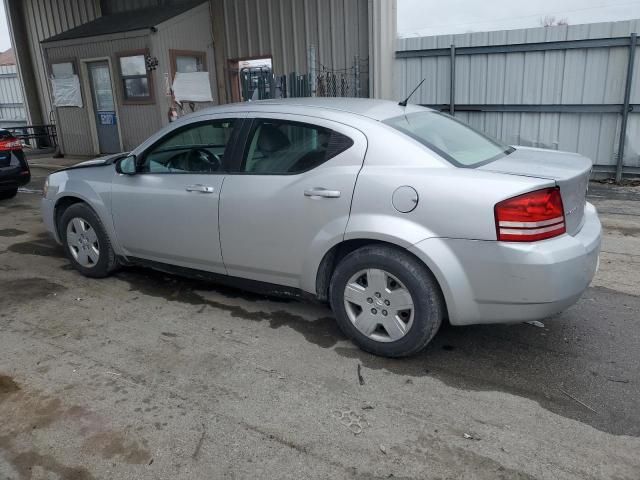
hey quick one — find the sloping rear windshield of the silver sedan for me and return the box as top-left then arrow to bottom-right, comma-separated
384,112 -> 514,167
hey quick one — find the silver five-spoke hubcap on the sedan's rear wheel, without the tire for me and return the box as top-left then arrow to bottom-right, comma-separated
344,268 -> 415,342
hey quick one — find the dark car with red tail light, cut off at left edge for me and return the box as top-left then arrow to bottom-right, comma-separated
0,129 -> 31,199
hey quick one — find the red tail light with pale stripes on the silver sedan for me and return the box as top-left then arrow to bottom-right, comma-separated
494,187 -> 567,242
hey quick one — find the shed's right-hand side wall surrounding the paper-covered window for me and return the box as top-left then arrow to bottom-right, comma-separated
151,3 -> 218,125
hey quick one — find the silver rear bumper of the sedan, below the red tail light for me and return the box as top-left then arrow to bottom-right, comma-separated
410,204 -> 602,325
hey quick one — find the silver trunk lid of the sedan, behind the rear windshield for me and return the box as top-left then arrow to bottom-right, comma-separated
479,147 -> 592,235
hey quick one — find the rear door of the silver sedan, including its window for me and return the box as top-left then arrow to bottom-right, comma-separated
220,114 -> 367,289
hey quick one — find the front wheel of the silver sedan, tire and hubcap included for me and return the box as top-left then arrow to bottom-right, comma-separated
58,203 -> 118,278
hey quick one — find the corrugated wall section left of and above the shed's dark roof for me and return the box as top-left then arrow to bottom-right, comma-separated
22,0 -> 100,122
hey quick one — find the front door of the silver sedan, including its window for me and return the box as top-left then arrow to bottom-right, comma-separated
112,118 -> 241,273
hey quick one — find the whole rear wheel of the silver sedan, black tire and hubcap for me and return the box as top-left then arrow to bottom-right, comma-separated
329,245 -> 445,357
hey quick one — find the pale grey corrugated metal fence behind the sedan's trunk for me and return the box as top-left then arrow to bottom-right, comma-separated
394,20 -> 640,171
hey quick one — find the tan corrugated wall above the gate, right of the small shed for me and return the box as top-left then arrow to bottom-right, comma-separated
211,0 -> 369,100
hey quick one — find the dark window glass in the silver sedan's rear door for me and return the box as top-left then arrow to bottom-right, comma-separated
241,119 -> 353,175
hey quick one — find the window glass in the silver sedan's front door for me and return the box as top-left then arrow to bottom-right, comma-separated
140,120 -> 235,173
